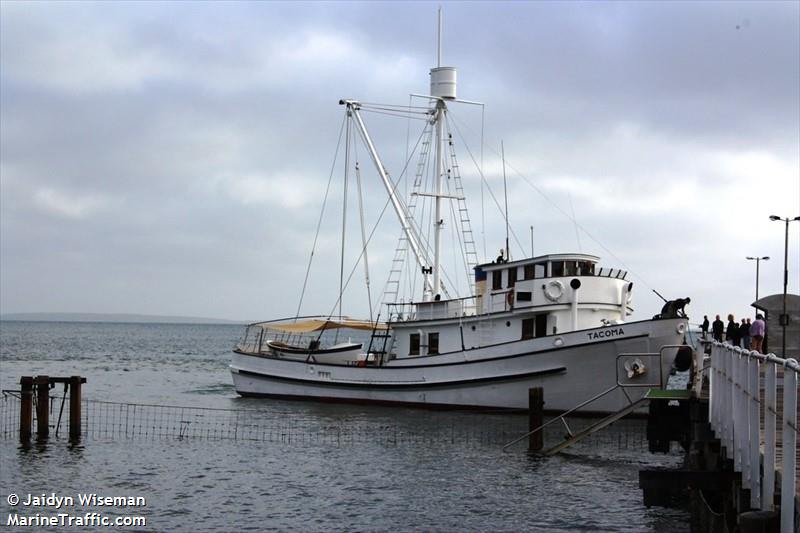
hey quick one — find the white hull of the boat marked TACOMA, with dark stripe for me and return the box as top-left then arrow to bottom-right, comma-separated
231,319 -> 687,414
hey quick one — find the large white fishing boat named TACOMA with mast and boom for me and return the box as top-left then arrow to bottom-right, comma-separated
230,12 -> 688,414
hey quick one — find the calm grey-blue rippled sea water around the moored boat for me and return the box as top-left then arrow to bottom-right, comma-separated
0,322 -> 689,532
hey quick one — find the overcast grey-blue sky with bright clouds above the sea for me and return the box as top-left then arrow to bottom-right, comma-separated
0,1 -> 800,321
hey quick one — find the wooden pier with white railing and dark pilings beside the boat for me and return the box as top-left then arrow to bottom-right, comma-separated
639,342 -> 800,533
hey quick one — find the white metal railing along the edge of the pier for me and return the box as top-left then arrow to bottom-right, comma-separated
704,341 -> 800,531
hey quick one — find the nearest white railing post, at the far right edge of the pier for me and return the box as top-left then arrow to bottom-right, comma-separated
781,359 -> 800,533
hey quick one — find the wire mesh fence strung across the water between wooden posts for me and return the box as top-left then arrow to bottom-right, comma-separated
0,392 -> 647,449
